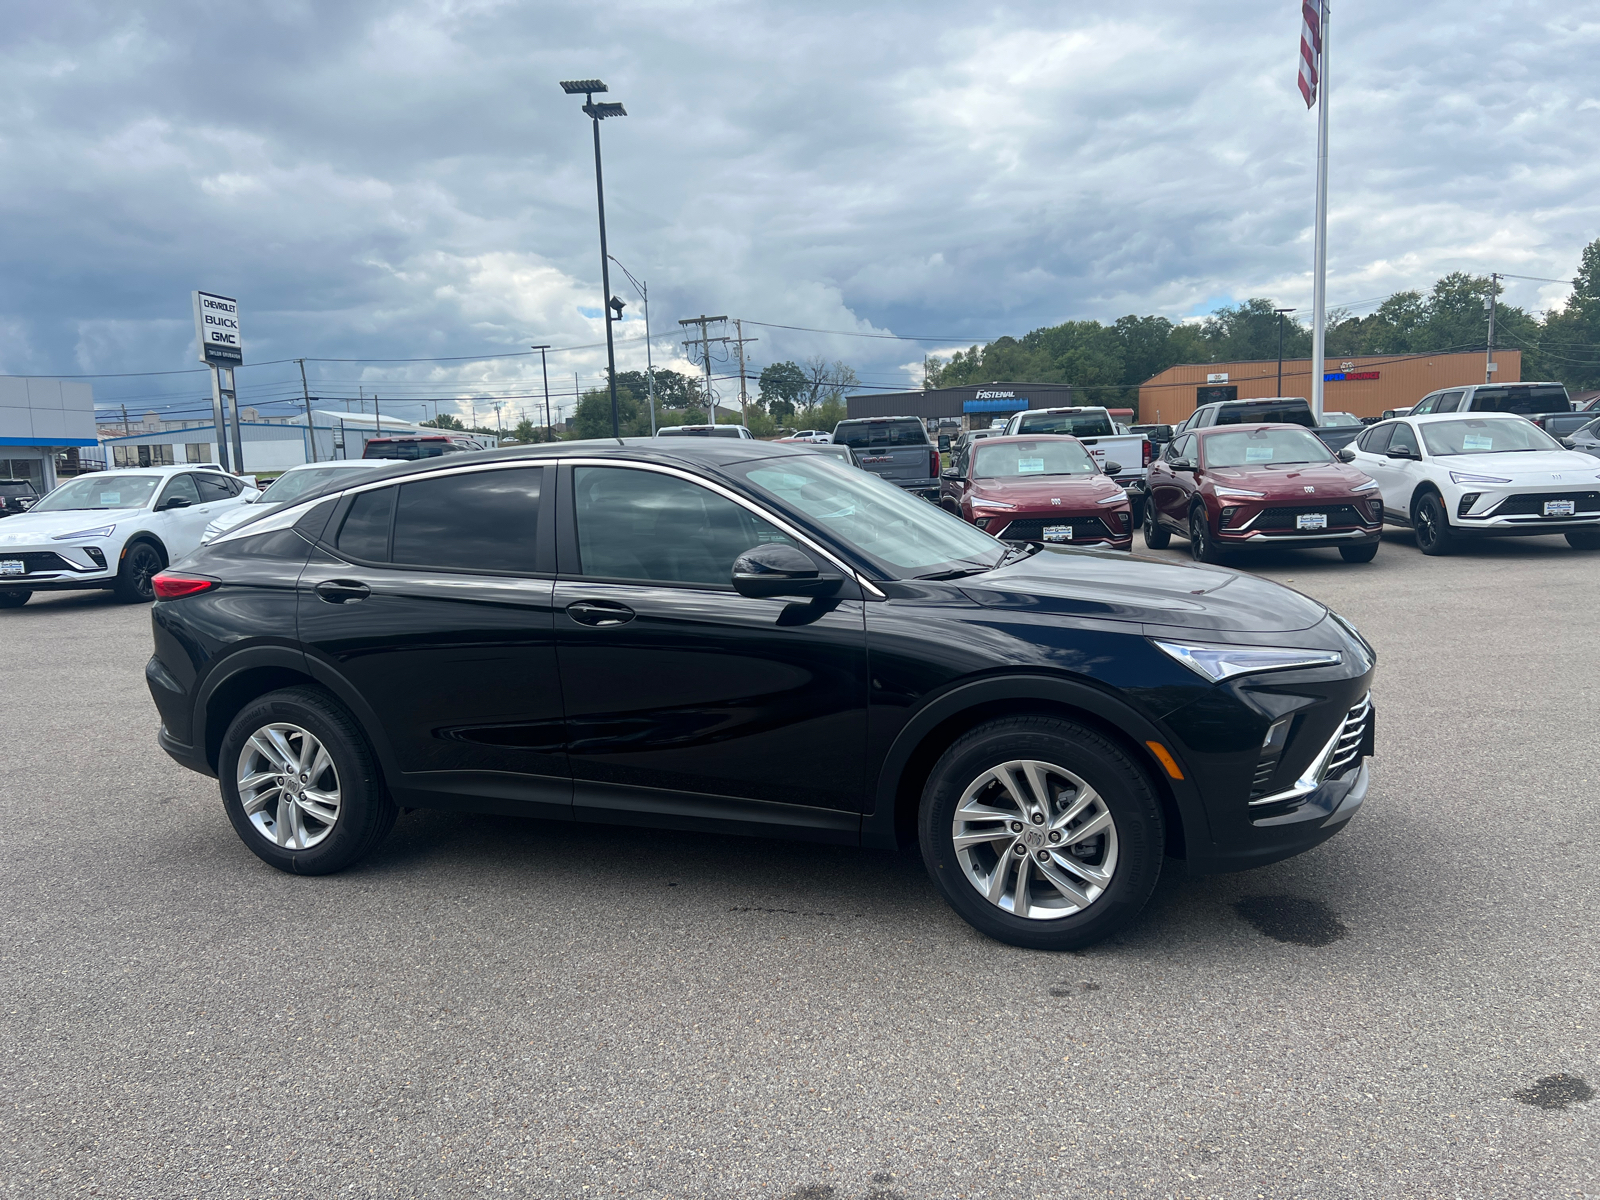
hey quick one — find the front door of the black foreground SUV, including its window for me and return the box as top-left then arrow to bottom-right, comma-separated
555,461 -> 867,842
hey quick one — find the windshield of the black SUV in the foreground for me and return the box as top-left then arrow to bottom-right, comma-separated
731,454 -> 1006,578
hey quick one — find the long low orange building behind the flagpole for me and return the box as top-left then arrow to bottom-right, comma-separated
1139,350 -> 1522,426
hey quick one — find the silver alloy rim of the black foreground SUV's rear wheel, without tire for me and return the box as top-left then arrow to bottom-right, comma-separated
237,723 -> 339,850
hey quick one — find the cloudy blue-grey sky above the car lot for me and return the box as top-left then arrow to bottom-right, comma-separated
0,0 -> 1600,418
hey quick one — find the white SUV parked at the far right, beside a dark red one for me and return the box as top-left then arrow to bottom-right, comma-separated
1339,413 -> 1600,554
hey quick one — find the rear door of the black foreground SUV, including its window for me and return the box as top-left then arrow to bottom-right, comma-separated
298,462 -> 571,818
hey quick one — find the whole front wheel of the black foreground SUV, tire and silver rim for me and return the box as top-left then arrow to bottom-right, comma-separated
918,715 -> 1165,950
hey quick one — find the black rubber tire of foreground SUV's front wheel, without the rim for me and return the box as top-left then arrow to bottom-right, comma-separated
918,715 -> 1166,950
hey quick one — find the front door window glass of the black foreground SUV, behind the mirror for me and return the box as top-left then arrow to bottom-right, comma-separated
573,467 -> 789,587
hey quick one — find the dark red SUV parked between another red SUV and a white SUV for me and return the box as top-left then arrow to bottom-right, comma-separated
1144,426 -> 1384,563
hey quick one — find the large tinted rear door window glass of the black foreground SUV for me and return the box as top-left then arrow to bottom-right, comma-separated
392,467 -> 544,573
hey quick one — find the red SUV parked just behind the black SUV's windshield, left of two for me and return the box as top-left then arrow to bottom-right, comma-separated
939,435 -> 1133,550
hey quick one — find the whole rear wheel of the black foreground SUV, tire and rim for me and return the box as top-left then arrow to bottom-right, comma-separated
218,688 -> 397,875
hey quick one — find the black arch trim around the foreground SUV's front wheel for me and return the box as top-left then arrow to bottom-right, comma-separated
861,674 -> 1211,853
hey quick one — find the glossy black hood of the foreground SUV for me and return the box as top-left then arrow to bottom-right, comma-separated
962,546 -> 1328,635
